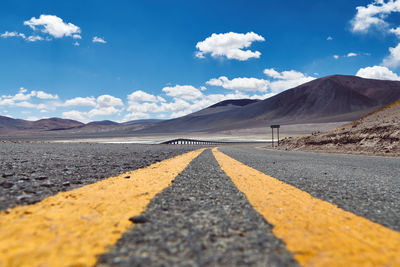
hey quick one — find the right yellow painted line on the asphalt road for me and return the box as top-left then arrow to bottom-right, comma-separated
213,149 -> 400,266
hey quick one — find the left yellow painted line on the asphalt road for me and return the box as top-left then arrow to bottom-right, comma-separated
0,149 -> 204,267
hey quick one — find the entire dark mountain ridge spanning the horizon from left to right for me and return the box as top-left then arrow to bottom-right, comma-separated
0,75 -> 400,135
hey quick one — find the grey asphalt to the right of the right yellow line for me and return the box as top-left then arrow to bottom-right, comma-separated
220,146 -> 400,231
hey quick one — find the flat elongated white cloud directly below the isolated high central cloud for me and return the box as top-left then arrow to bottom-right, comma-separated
206,76 -> 269,92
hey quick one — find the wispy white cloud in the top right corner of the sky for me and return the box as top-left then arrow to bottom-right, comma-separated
351,0 -> 400,33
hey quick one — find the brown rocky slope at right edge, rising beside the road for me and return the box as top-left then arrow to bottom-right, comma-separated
281,99 -> 400,156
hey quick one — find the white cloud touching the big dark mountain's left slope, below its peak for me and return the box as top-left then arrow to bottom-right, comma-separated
264,69 -> 315,94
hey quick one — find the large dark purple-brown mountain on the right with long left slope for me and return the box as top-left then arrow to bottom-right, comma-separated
140,75 -> 400,133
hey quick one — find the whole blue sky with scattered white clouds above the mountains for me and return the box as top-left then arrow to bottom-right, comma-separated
0,0 -> 400,123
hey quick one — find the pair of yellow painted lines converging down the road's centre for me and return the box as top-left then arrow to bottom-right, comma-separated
0,149 -> 400,267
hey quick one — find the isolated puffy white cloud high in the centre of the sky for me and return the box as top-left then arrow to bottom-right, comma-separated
196,32 -> 265,61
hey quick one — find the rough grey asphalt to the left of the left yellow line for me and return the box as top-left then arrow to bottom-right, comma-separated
0,142 -> 198,210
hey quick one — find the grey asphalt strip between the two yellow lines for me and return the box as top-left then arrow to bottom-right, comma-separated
98,150 -> 297,266
